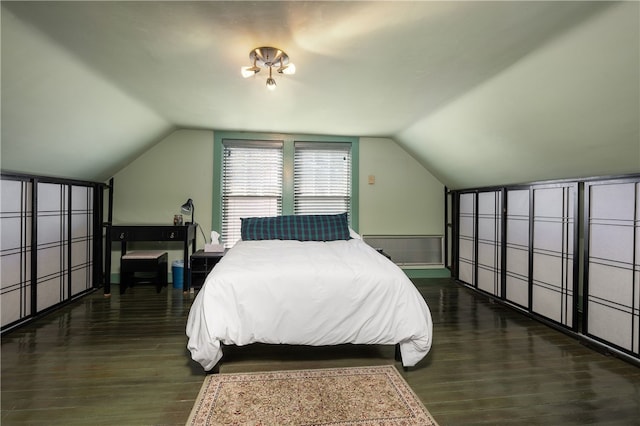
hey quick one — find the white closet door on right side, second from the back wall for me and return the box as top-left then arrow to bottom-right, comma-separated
477,191 -> 502,297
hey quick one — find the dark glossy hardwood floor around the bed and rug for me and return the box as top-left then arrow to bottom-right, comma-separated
1,279 -> 640,425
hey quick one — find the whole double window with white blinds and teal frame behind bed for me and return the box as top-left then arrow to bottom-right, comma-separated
211,132 -> 358,247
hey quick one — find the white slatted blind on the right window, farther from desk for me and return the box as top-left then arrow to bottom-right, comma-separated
294,142 -> 351,216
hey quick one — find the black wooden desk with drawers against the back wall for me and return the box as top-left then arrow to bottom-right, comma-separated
104,223 -> 198,295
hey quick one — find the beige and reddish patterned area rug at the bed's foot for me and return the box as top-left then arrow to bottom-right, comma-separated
187,365 -> 437,426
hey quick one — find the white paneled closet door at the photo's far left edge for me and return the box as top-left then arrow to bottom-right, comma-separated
0,178 -> 33,327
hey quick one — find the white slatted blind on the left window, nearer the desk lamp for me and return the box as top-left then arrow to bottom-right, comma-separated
222,141 -> 283,247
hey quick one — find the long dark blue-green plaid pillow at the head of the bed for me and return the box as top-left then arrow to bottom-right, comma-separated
240,213 -> 351,241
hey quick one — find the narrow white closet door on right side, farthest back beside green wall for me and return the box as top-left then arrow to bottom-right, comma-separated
458,193 -> 476,286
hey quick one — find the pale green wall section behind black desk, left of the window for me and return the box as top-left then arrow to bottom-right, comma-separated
111,130 -> 213,281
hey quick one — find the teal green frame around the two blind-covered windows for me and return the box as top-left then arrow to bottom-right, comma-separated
211,131 -> 360,236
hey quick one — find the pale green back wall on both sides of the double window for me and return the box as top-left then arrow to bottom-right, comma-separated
111,129 -> 444,281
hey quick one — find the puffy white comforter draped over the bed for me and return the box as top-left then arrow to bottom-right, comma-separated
186,239 -> 432,370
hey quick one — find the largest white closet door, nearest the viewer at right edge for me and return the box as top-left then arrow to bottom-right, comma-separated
584,179 -> 640,355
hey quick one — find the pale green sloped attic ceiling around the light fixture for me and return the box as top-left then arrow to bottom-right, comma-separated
1,1 -> 640,188
